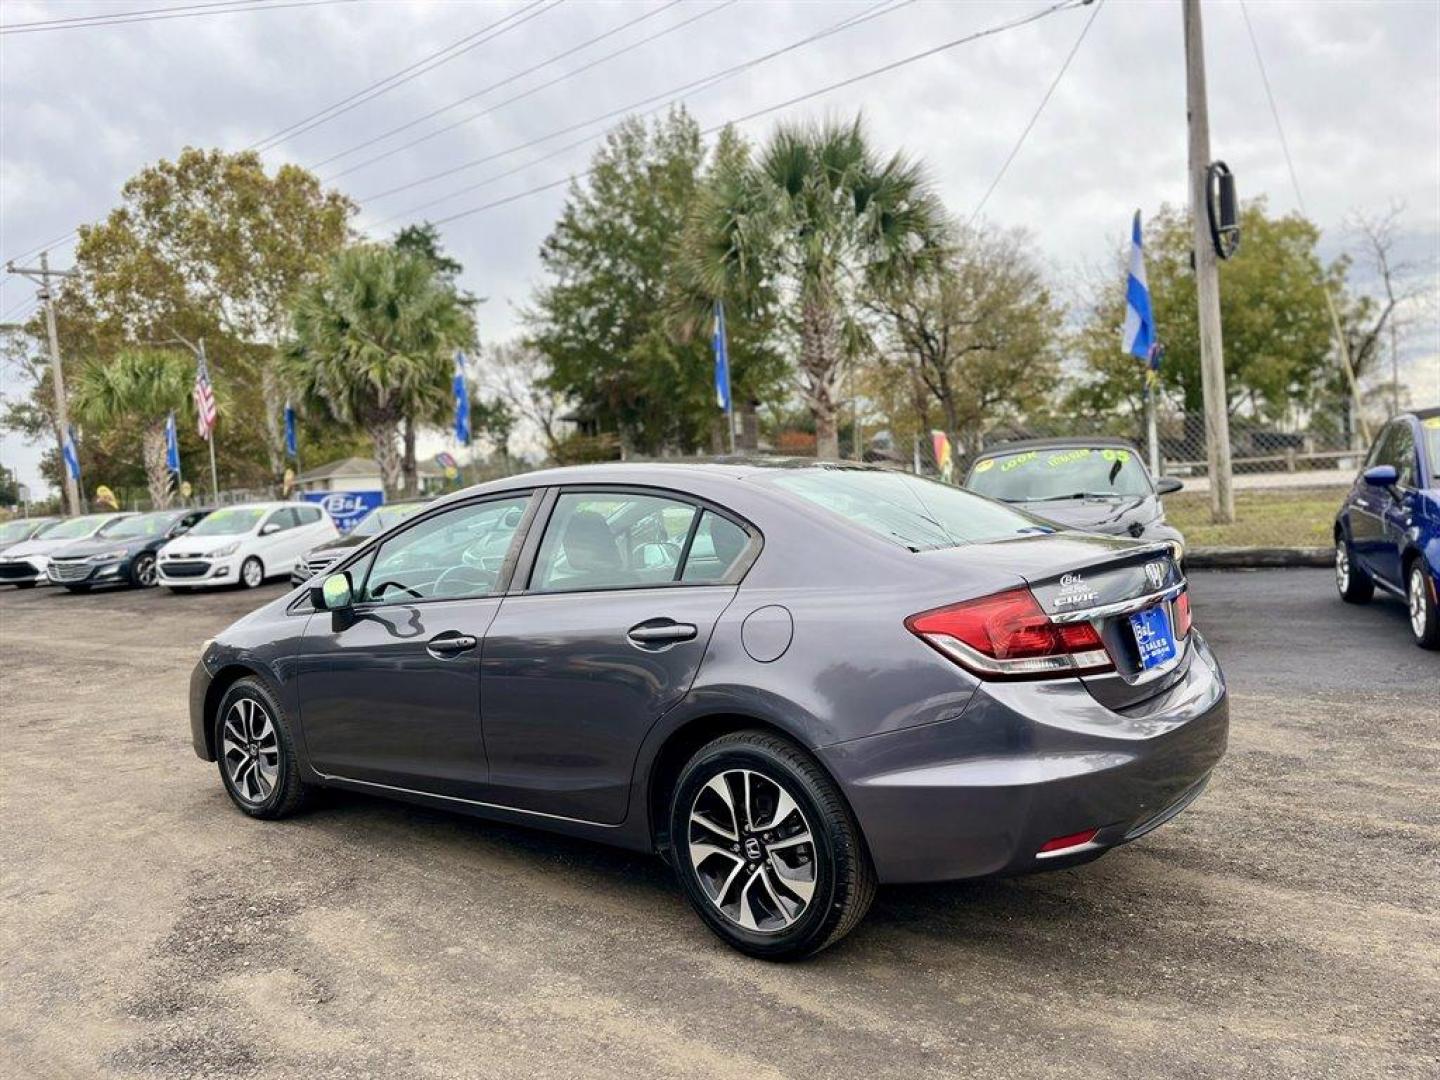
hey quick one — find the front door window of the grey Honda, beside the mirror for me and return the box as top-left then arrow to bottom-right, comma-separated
360,495 -> 530,603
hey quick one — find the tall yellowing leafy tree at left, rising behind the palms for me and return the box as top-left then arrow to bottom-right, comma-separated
62,148 -> 356,480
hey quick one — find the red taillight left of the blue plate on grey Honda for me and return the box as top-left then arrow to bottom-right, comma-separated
906,589 -> 1113,678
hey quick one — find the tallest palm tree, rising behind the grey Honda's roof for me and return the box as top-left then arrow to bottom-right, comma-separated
683,117 -> 946,458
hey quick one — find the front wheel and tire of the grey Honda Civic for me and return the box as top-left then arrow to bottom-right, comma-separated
215,678 -> 305,819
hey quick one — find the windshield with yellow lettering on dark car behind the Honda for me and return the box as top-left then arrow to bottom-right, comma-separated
965,446 -> 1151,503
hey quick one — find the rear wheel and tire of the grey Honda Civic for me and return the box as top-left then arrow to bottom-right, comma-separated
670,732 -> 876,960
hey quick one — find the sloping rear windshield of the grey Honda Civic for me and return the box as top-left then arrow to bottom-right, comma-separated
770,468 -> 1056,552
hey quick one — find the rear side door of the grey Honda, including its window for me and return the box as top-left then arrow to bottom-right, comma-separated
481,488 -> 757,824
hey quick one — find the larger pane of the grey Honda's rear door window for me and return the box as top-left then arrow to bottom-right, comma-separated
530,492 -> 698,592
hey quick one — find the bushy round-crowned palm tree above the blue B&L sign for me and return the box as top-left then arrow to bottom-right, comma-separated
284,243 -> 475,497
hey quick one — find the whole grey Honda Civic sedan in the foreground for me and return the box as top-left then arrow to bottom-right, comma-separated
190,462 -> 1228,959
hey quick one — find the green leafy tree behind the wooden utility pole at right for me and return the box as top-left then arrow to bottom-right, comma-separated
1071,199 -> 1345,420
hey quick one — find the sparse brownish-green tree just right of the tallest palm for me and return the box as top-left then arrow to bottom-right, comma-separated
873,229 -> 1063,449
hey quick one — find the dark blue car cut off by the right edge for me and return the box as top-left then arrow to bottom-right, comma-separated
1335,409 -> 1440,649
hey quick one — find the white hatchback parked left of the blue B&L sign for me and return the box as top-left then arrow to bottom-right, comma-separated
156,503 -> 340,592
